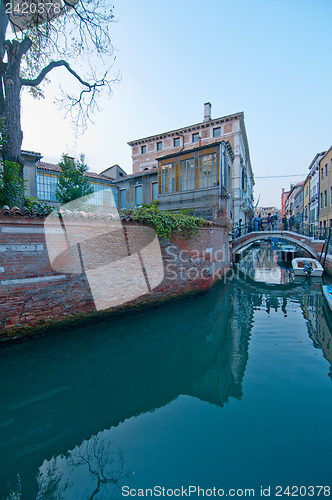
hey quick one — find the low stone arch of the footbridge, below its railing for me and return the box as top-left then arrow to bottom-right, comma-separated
232,230 -> 324,260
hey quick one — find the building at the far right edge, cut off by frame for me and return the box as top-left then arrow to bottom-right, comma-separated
318,146 -> 332,228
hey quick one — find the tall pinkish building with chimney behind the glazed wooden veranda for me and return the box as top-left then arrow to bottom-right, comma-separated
128,103 -> 254,223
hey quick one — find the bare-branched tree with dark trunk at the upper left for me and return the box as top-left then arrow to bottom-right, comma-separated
0,0 -> 117,165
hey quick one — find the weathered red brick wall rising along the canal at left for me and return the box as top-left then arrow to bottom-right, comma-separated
0,216 -> 231,341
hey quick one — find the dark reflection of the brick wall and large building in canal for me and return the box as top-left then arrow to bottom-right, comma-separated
0,285 -> 253,498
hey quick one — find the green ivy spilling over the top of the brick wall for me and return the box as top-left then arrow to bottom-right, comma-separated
119,206 -> 206,238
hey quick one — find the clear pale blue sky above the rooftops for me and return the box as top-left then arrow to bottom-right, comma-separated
22,0 -> 332,206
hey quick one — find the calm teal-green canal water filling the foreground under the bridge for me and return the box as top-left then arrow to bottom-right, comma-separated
0,249 -> 332,500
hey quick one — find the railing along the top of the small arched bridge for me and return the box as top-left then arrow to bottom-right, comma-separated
233,221 -> 329,240
